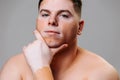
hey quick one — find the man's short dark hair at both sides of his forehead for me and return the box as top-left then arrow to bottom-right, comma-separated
38,0 -> 82,16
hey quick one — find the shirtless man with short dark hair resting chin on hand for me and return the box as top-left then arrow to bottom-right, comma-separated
0,0 -> 119,80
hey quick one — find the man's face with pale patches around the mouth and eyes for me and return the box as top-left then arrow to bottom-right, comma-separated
37,0 -> 83,48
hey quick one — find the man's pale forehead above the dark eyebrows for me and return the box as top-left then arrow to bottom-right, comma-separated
40,0 -> 74,12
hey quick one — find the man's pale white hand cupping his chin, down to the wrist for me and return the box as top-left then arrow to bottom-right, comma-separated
23,30 -> 67,72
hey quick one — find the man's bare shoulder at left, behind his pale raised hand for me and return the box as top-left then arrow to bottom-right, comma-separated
0,54 -> 31,80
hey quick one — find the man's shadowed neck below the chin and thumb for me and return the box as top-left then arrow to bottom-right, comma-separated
51,40 -> 77,75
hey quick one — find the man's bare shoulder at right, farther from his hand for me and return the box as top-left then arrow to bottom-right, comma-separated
79,49 -> 119,80
